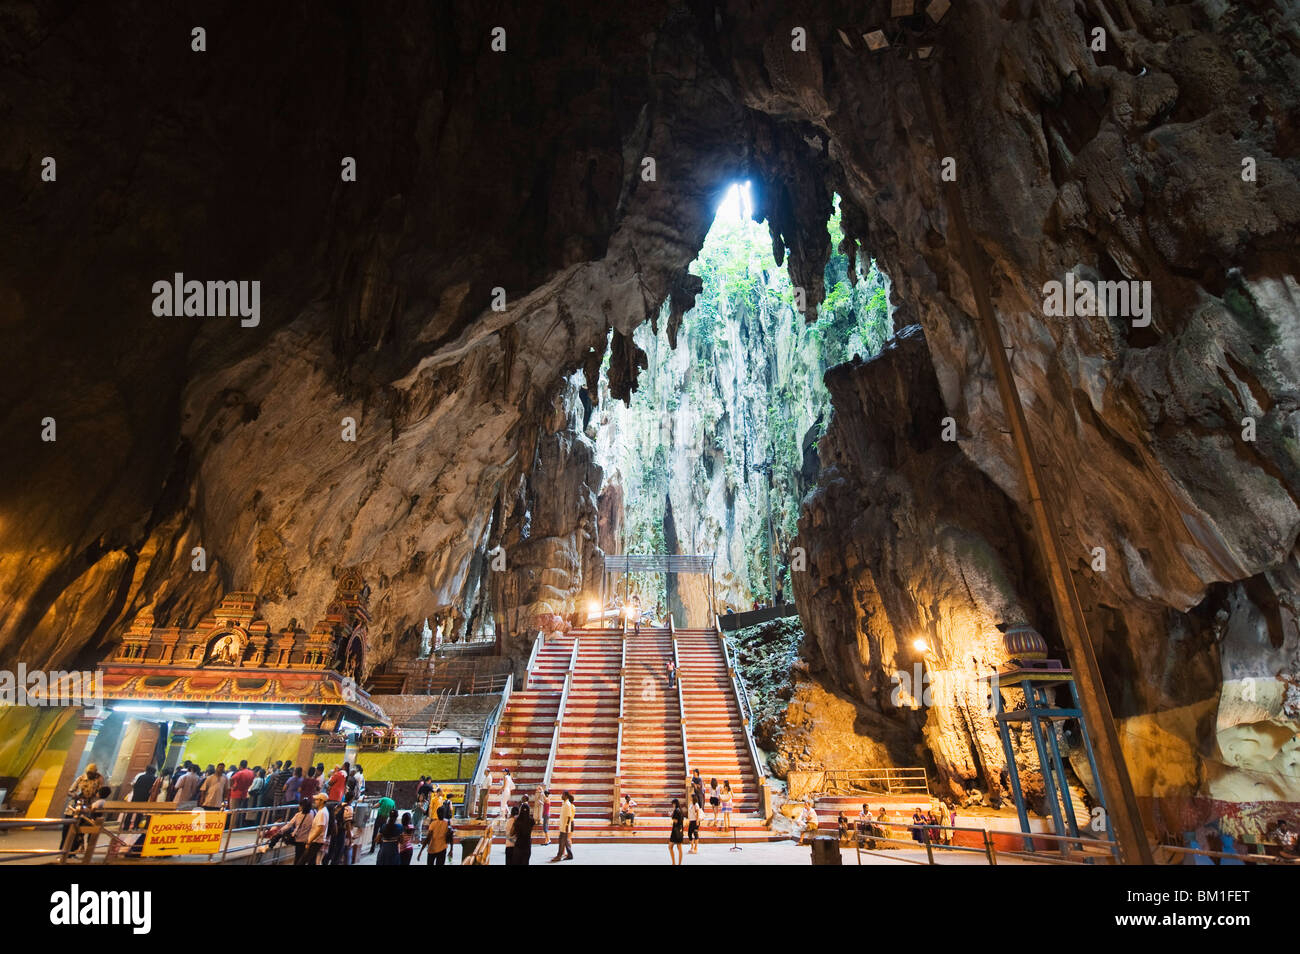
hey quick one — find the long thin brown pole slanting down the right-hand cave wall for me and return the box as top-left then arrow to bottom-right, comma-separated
909,50 -> 1153,864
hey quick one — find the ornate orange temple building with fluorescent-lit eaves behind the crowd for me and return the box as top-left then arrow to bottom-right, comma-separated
14,571 -> 389,815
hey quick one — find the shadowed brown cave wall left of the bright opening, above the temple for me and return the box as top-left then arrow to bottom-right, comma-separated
0,4 -> 746,665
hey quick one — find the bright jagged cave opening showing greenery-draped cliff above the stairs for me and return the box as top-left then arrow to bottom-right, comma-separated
586,181 -> 892,626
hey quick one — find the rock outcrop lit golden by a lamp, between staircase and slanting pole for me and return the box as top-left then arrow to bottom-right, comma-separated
795,325 -> 1050,798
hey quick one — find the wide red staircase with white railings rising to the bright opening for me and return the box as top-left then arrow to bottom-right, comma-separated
489,626 -> 774,842
